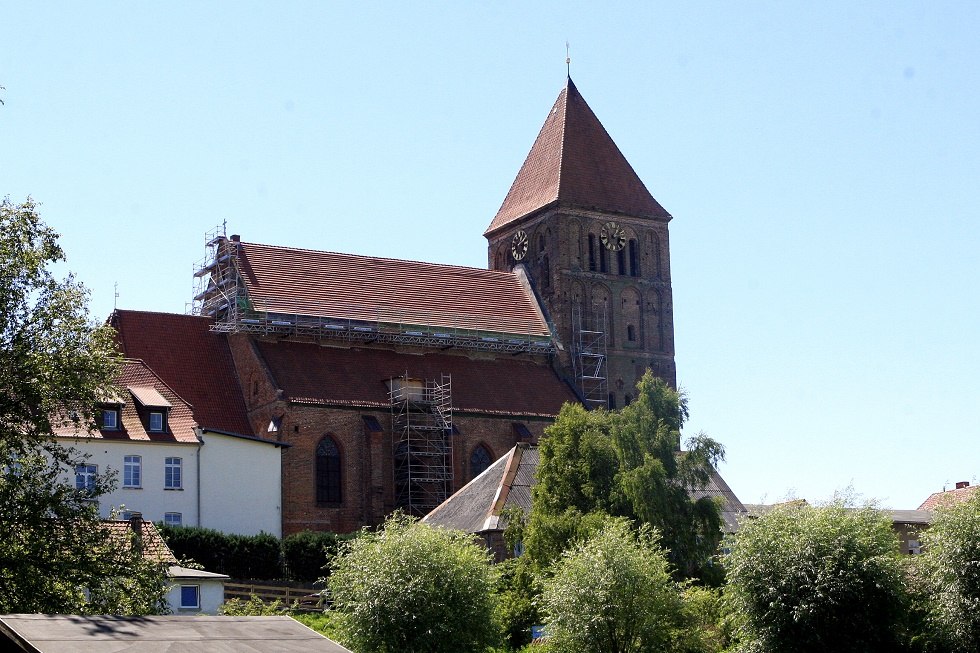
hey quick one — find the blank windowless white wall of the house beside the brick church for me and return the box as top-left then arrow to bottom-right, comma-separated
201,431 -> 283,537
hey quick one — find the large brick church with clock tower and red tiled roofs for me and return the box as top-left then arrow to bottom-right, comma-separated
110,79 -> 692,535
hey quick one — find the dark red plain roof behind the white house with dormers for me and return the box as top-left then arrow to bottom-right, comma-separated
109,310 -> 254,435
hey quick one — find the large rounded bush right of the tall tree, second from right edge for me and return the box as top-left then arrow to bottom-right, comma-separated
726,500 -> 907,653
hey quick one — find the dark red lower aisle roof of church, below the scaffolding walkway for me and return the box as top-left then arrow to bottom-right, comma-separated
256,341 -> 576,416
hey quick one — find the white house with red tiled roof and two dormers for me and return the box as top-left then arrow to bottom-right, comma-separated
58,359 -> 282,537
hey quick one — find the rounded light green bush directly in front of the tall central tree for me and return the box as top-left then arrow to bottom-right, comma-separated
543,519 -> 683,653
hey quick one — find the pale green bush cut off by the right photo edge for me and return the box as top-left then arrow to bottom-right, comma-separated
914,492 -> 980,651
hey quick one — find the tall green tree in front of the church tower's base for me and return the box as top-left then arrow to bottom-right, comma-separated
526,371 -> 724,578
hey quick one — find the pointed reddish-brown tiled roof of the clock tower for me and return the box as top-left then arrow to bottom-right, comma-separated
486,78 -> 670,234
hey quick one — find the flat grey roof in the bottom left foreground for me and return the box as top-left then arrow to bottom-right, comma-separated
0,614 -> 350,653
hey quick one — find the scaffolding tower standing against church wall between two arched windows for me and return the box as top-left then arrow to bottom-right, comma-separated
389,373 -> 453,517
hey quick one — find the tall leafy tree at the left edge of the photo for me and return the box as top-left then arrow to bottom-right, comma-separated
0,199 -> 165,614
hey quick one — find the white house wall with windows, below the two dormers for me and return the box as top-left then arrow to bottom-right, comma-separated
58,438 -> 202,526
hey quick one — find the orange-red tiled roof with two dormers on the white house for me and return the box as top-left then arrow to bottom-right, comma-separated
54,358 -> 198,443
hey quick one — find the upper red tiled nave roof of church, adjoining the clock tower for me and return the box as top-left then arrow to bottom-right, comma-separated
231,243 -> 550,336
